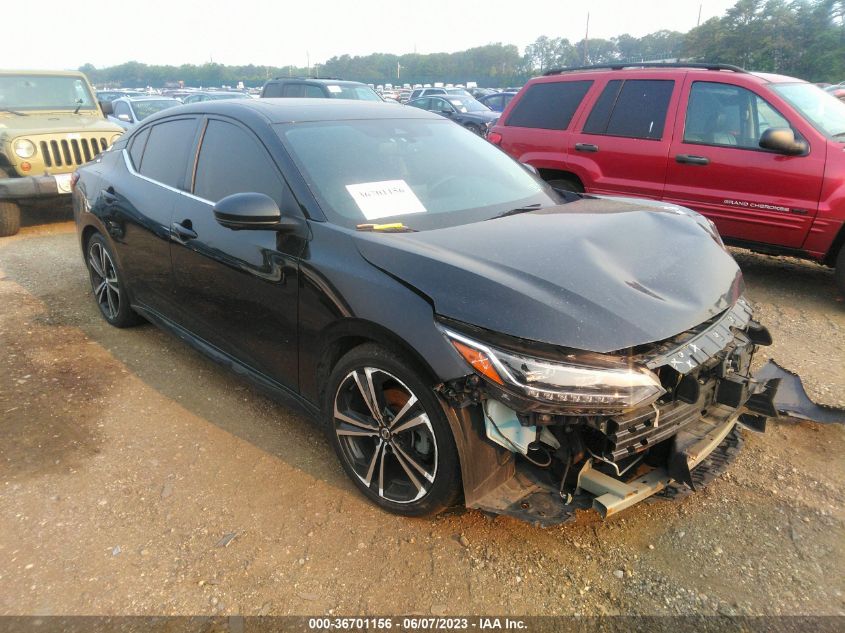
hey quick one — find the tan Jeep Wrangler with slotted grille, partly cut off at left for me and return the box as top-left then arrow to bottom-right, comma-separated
0,70 -> 123,237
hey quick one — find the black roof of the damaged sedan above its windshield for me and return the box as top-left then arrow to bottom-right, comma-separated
148,98 -> 443,123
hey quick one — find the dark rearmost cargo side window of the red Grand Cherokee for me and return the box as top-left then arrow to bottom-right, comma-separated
505,80 -> 593,130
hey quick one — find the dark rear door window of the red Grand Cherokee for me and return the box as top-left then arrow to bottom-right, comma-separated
583,79 -> 675,140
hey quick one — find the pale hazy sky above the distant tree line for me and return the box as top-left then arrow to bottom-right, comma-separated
0,0 -> 736,69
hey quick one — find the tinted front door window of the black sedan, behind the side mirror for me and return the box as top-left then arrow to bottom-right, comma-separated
194,119 -> 284,204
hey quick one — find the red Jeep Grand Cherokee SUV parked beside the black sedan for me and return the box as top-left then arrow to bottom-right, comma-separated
488,64 -> 845,294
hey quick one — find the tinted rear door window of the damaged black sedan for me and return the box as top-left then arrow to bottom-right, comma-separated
140,118 -> 197,189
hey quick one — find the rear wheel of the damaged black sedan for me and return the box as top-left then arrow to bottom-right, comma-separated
85,233 -> 141,328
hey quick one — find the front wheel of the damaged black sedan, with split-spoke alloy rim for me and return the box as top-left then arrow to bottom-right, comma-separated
325,344 -> 461,516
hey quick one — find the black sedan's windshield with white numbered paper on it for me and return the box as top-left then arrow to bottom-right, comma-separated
276,119 -> 560,230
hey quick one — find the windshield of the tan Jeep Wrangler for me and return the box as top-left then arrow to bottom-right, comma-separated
0,75 -> 96,110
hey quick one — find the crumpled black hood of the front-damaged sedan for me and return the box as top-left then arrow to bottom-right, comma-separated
356,198 -> 743,352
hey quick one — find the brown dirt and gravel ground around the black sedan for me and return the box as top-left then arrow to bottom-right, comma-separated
0,222 -> 845,615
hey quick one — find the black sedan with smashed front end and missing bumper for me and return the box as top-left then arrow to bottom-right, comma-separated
73,99 -> 771,523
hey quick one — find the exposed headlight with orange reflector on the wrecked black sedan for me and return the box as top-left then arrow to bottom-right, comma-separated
443,329 -> 665,413
